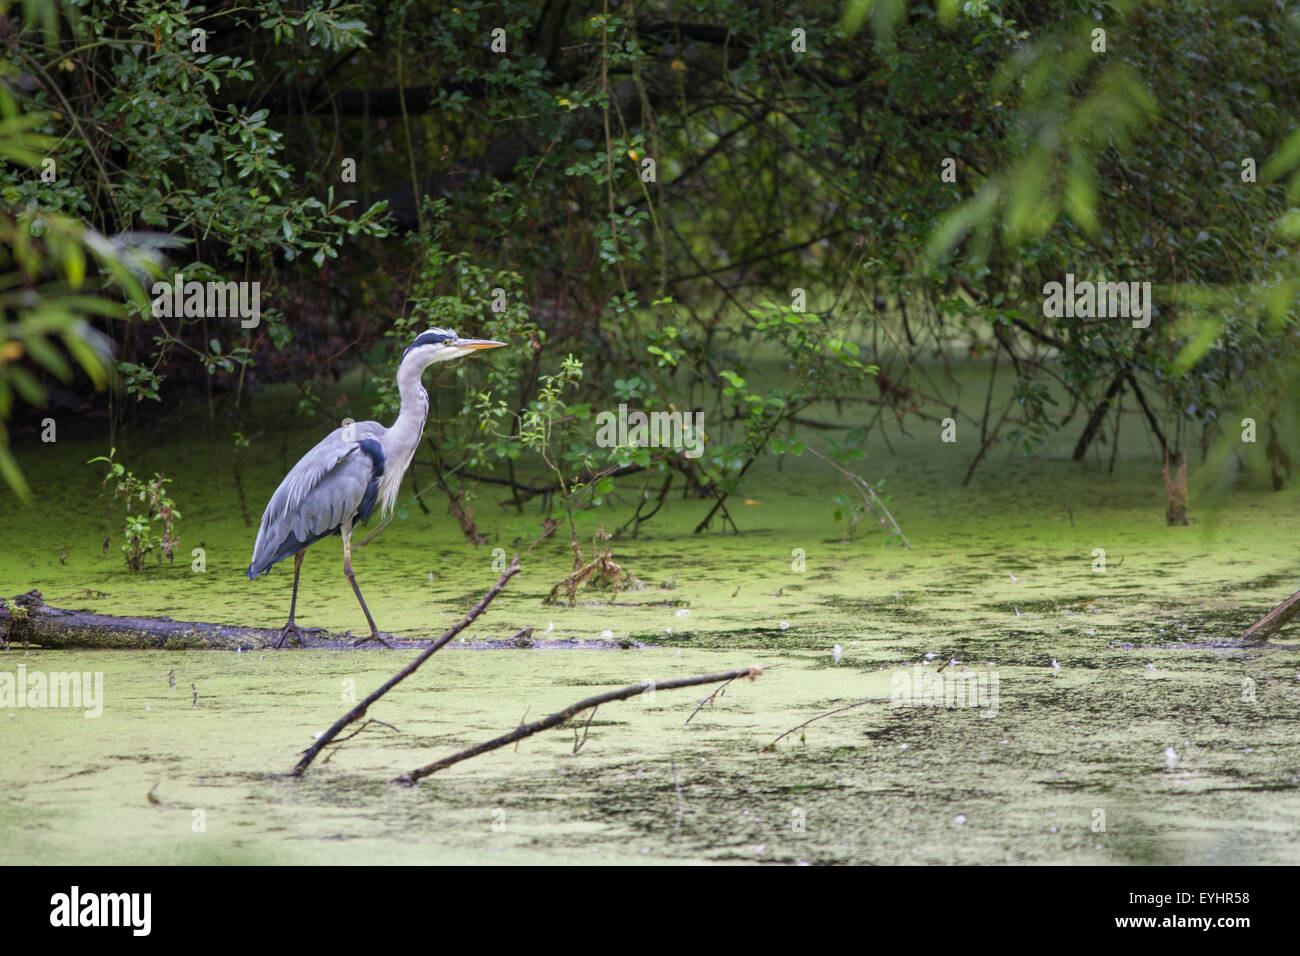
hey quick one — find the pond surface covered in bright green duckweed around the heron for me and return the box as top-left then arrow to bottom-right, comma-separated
0,361 -> 1300,864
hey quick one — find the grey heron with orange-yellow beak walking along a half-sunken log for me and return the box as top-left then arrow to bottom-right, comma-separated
247,329 -> 506,648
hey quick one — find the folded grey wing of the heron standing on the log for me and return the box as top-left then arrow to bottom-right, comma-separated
247,421 -> 384,578
